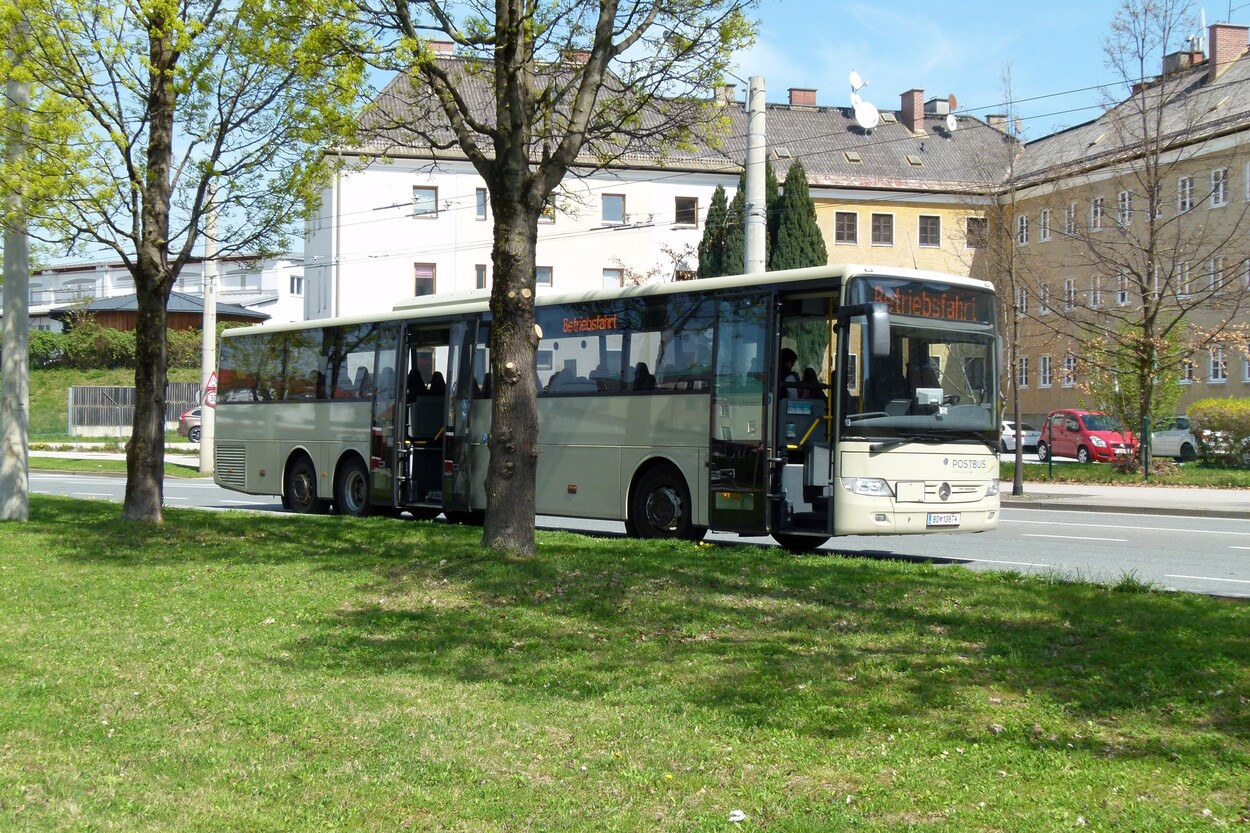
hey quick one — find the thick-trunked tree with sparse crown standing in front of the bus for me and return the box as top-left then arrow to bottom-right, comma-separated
371,0 -> 754,554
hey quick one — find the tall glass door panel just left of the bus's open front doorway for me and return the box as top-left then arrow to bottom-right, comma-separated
708,293 -> 775,534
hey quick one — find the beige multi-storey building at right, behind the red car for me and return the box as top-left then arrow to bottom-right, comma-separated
998,24 -> 1250,420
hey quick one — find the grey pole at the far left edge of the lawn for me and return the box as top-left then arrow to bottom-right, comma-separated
0,32 -> 30,520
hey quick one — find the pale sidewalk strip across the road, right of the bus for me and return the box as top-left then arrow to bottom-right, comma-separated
1001,480 -> 1250,520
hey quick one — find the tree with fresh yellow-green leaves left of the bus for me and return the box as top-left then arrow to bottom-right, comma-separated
21,0 -> 364,522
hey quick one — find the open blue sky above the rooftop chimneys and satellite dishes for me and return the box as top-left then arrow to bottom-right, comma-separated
736,0 -> 1250,140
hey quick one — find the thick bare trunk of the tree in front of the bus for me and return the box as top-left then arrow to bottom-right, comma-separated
481,196 -> 539,555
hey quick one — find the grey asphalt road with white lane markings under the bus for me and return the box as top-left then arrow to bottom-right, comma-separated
30,472 -> 1250,598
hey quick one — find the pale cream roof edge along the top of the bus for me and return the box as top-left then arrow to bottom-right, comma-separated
226,264 -> 994,335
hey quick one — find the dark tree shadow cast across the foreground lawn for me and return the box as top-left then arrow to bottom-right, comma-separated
33,499 -> 1250,760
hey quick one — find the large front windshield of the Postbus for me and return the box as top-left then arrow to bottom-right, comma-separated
841,315 -> 998,443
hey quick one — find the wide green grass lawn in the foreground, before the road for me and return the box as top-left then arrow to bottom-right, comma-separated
0,495 -> 1250,832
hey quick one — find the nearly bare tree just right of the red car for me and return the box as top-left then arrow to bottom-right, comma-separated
1018,0 -> 1250,453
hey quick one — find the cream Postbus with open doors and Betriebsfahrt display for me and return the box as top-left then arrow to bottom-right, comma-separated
214,265 -> 1003,552
